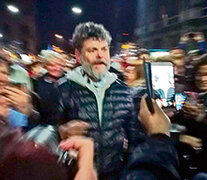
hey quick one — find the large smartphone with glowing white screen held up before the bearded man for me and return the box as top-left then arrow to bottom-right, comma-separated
151,61 -> 175,107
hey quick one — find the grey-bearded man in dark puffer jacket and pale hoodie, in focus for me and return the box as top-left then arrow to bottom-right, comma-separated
57,22 -> 180,179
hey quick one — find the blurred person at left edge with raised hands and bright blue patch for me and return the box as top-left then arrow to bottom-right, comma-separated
0,58 -> 32,127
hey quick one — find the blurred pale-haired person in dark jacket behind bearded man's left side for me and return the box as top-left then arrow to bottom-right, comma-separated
34,50 -> 67,125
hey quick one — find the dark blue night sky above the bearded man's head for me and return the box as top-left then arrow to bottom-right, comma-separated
35,0 -> 137,51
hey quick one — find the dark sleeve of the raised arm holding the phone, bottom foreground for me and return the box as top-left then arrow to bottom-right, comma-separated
121,135 -> 180,180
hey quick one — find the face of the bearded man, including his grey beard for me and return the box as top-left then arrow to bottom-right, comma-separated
76,39 -> 110,81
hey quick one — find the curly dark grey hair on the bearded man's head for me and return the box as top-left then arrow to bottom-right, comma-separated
72,22 -> 112,51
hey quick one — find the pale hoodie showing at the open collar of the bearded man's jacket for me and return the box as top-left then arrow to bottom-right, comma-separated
67,66 -> 117,125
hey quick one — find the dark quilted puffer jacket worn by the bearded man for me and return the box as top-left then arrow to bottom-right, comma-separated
58,80 -> 146,179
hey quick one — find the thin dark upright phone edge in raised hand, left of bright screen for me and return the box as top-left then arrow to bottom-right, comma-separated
143,57 -> 154,114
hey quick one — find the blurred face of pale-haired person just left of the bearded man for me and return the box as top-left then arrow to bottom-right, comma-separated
45,57 -> 63,78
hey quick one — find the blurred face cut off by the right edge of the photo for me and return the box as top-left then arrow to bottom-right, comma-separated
196,65 -> 207,92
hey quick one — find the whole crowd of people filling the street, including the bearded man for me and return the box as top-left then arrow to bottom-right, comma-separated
0,22 -> 207,180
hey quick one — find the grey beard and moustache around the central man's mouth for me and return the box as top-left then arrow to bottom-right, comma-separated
81,57 -> 110,81
